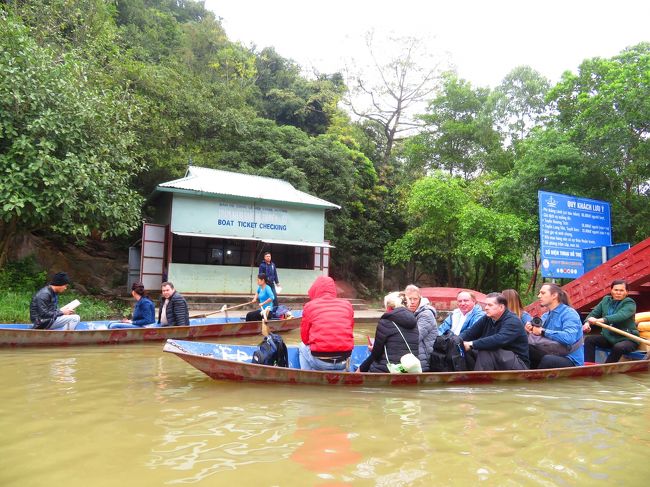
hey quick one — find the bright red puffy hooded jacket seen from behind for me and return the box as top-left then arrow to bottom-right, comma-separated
300,276 -> 354,353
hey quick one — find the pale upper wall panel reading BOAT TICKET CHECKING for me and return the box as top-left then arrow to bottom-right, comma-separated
171,194 -> 325,242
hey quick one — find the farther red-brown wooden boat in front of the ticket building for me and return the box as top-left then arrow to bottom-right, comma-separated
0,311 -> 301,347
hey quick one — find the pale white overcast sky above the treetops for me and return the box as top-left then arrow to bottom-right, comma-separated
205,0 -> 650,87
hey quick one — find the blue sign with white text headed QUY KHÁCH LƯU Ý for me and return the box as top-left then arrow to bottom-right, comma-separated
537,191 -> 612,279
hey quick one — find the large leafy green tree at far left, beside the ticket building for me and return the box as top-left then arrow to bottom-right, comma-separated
0,15 -> 142,264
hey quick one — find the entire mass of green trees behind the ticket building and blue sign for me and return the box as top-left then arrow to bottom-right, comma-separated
0,0 -> 650,296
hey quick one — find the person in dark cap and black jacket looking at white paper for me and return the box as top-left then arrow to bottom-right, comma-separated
29,272 -> 80,330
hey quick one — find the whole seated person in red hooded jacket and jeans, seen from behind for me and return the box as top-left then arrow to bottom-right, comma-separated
300,276 -> 354,370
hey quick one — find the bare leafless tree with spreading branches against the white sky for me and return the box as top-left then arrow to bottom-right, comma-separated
346,32 -> 440,173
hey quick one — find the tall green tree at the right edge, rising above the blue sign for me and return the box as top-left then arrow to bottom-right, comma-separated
549,43 -> 650,242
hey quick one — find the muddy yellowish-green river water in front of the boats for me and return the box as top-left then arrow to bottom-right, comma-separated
0,331 -> 650,487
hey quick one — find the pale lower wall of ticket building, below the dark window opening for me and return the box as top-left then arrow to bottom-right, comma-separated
169,263 -> 322,296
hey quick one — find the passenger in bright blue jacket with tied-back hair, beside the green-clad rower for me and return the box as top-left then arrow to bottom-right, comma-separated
525,284 -> 585,369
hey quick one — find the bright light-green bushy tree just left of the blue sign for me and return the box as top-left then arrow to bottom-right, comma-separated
386,172 -> 526,289
